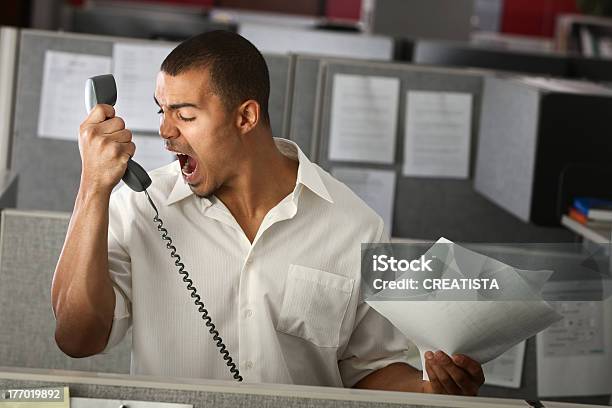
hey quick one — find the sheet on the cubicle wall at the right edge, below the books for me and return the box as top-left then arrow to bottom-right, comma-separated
536,281 -> 612,397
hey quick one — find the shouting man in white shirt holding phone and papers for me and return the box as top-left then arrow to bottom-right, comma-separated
52,31 -> 484,395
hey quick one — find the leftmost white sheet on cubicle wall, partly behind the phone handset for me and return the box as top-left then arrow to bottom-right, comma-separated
37,50 -> 111,141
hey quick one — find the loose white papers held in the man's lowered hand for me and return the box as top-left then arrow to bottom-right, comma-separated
366,238 -> 562,380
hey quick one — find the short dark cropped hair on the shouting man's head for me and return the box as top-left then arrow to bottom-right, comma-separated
161,30 -> 270,125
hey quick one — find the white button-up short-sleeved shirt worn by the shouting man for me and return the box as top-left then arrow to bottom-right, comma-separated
105,139 -> 418,387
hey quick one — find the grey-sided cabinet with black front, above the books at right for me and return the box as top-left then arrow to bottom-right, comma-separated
475,77 -> 612,225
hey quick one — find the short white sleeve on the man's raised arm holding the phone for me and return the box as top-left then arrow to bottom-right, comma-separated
102,193 -> 132,354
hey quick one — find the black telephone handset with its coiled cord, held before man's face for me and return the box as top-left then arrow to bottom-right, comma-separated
85,74 -> 242,381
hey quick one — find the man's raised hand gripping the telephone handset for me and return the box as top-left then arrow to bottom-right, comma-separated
79,104 -> 136,194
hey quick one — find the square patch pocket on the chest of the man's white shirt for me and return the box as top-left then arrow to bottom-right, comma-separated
276,264 -> 355,347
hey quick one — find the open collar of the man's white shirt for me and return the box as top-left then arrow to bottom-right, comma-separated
166,137 -> 334,205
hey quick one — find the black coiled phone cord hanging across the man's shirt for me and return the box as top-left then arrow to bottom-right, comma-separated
144,190 -> 242,381
